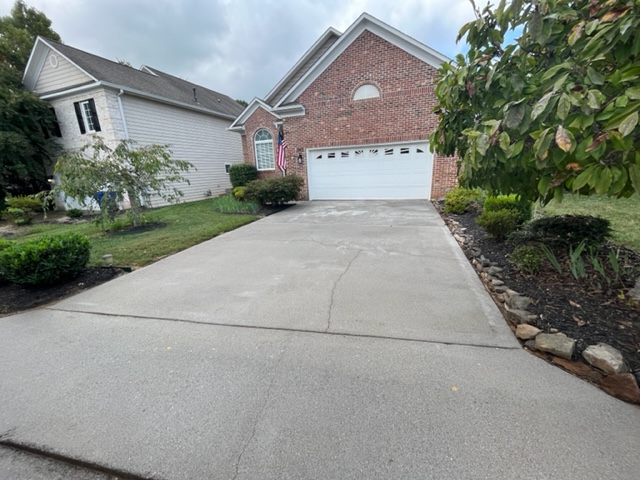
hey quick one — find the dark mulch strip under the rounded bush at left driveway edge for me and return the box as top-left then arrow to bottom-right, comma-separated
0,267 -> 124,317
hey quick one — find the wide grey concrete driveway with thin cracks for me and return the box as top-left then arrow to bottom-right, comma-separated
0,202 -> 640,479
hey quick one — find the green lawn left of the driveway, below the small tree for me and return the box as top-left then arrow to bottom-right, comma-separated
12,199 -> 258,267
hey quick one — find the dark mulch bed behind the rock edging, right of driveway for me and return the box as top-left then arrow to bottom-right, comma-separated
440,204 -> 640,377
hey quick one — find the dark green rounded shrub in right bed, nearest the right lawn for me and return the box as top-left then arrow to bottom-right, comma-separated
528,215 -> 611,248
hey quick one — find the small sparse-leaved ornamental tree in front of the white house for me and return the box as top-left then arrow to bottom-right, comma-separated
55,137 -> 193,226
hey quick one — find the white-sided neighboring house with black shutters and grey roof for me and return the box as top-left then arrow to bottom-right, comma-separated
23,37 -> 243,206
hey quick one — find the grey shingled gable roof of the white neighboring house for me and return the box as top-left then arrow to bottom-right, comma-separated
23,37 -> 243,118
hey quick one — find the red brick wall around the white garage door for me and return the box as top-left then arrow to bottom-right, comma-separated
238,31 -> 456,198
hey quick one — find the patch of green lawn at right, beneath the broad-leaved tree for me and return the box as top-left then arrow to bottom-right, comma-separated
538,194 -> 640,252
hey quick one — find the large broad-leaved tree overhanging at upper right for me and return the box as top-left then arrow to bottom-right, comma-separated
431,0 -> 640,202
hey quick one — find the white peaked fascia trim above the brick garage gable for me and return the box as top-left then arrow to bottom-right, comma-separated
274,13 -> 451,109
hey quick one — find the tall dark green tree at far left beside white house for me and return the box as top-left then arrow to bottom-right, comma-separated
0,0 -> 60,209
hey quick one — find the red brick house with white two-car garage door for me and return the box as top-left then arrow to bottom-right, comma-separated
230,13 -> 456,200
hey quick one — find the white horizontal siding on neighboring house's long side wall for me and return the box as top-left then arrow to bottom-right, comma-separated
122,95 -> 243,206
